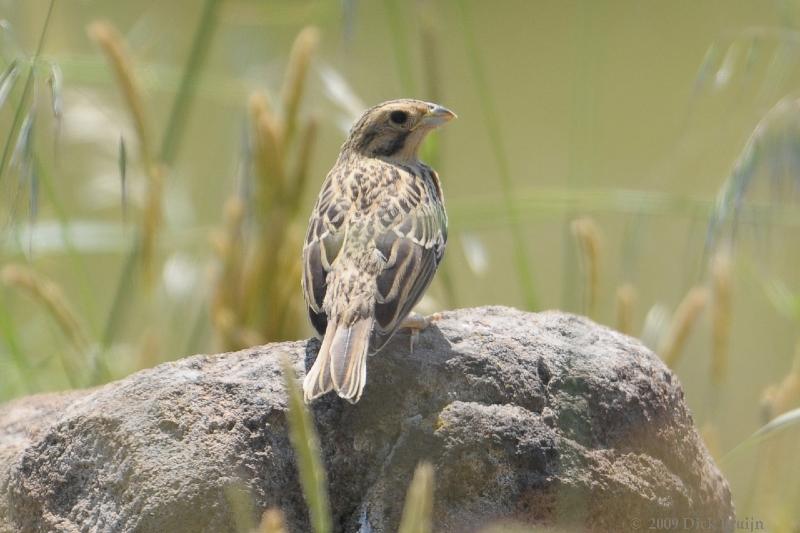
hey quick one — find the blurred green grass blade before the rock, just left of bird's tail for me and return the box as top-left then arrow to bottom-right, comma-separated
282,355 -> 331,533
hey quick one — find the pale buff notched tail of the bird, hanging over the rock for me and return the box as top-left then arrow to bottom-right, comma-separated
303,318 -> 373,403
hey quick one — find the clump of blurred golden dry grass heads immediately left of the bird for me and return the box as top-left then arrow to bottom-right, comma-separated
212,28 -> 319,349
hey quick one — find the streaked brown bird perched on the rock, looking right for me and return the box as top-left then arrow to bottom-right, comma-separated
302,100 -> 456,403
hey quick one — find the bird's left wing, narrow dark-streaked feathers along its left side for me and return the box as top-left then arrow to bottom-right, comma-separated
302,175 -> 349,336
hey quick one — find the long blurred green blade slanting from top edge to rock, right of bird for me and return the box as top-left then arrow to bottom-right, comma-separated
458,0 -> 539,309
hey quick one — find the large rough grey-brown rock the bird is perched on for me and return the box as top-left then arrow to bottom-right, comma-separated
0,307 -> 734,533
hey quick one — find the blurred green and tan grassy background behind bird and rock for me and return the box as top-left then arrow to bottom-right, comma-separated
0,0 -> 800,531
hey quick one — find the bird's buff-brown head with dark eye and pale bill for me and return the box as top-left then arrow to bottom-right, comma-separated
342,100 -> 456,161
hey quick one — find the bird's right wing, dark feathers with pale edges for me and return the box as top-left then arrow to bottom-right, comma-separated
372,191 -> 447,351
